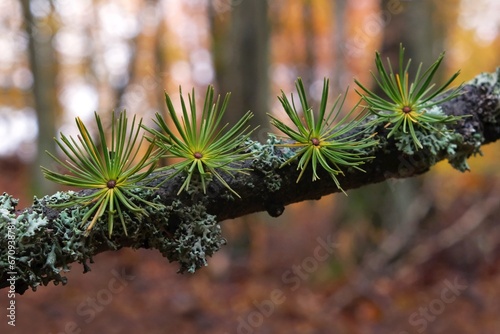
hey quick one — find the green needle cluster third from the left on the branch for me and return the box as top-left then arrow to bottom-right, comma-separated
269,78 -> 377,189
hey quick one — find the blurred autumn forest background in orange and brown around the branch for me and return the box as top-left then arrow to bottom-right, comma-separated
0,0 -> 500,334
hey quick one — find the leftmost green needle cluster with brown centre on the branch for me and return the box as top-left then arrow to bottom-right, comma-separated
42,111 -> 163,236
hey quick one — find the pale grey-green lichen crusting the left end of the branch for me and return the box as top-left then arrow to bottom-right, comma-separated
0,188 -> 226,290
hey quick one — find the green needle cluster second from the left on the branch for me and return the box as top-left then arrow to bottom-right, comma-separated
146,86 -> 253,197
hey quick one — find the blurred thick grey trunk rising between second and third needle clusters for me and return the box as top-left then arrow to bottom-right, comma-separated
211,0 -> 270,130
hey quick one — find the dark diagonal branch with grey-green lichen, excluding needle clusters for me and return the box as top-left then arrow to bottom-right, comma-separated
0,69 -> 500,294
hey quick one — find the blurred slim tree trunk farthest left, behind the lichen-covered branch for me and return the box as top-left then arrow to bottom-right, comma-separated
21,0 -> 57,196
